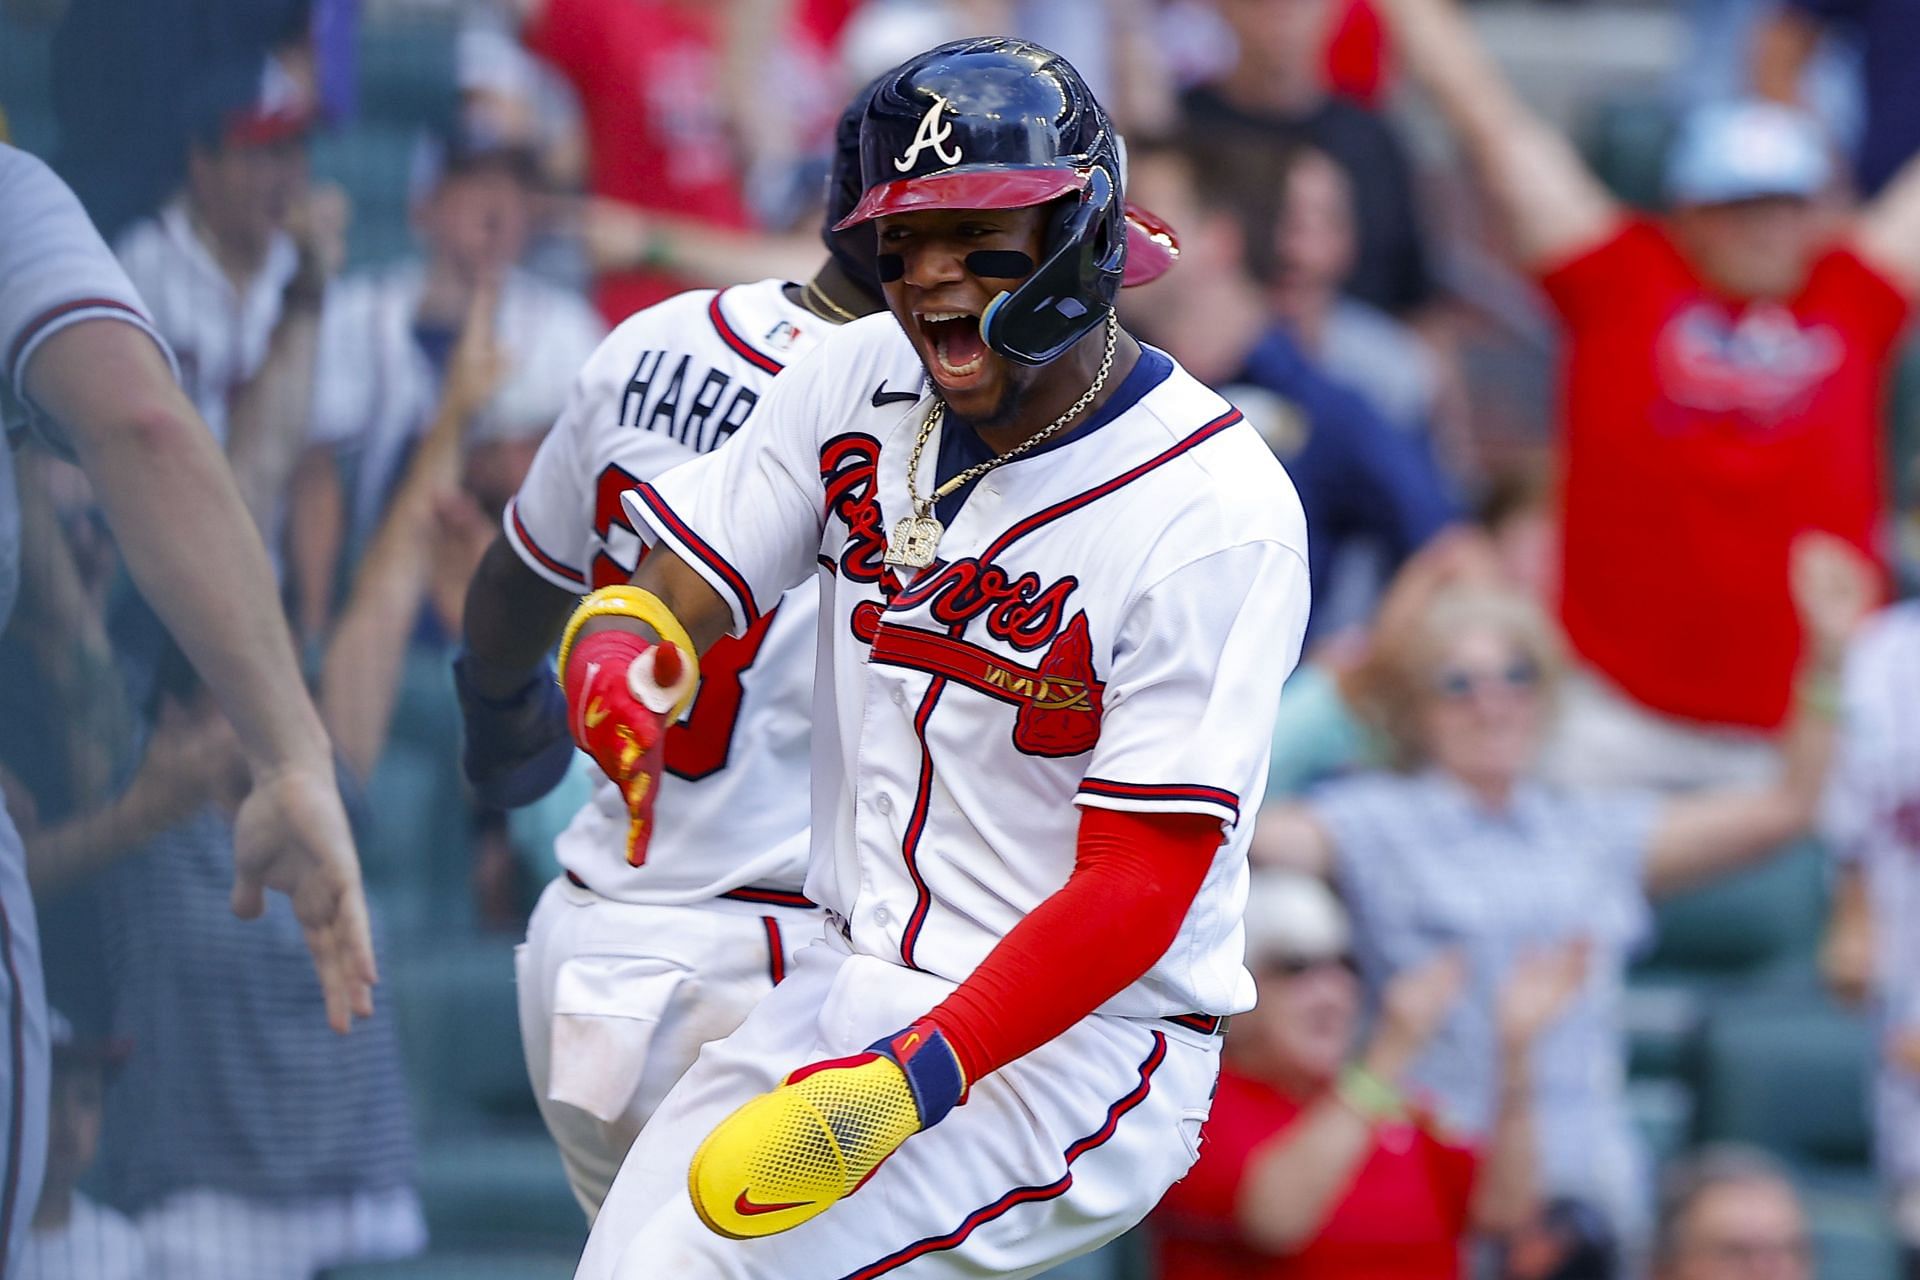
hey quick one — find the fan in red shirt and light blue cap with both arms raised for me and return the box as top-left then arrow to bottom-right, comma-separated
1380,0 -> 1920,781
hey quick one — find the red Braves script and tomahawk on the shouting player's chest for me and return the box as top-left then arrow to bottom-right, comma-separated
820,436 -> 1104,756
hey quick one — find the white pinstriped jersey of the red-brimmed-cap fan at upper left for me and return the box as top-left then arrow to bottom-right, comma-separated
115,200 -> 300,445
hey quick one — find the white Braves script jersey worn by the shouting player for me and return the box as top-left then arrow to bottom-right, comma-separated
624,315 -> 1308,1017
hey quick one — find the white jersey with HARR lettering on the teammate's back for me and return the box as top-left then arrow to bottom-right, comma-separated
505,280 -> 831,904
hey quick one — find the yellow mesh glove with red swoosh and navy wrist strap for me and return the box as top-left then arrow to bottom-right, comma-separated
687,1023 -> 966,1240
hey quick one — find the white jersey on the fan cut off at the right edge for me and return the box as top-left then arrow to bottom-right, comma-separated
1820,601 -> 1920,1186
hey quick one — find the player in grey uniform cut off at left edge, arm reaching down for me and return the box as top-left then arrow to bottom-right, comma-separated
0,146 -> 374,1272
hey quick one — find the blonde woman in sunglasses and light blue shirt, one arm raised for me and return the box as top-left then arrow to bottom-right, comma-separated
1254,533 -> 1878,1242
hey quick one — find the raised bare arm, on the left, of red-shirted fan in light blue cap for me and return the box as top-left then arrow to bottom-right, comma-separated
1380,0 -> 1620,271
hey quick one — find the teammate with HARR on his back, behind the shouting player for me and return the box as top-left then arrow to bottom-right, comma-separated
455,92 -> 881,1221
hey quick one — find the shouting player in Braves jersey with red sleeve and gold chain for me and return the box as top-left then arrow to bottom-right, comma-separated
561,38 -> 1308,1280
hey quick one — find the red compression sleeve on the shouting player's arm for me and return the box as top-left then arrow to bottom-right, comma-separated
927,808 -> 1221,1080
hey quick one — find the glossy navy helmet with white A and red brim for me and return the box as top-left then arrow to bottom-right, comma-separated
835,36 -> 1129,365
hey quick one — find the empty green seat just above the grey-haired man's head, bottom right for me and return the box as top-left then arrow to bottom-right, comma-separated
1699,992 -> 1872,1173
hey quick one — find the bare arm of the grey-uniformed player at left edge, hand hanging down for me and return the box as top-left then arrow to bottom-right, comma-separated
25,319 -> 374,1031
